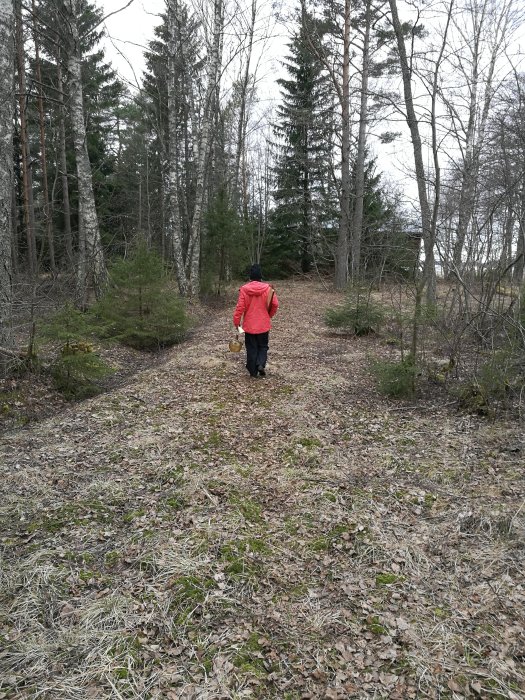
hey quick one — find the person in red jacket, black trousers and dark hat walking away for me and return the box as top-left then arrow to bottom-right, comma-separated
233,265 -> 279,377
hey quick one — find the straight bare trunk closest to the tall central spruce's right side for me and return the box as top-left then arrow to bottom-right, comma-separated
335,0 -> 351,289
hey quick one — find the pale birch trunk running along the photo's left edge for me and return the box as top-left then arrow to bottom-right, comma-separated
0,0 -> 15,360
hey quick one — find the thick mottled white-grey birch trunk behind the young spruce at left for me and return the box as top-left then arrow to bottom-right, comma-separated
67,0 -> 107,308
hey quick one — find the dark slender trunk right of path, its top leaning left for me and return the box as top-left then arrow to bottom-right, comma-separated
389,0 -> 436,304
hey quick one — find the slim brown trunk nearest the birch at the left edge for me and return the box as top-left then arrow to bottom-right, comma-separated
15,0 -> 38,276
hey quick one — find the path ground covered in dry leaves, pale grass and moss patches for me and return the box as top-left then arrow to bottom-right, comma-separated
0,282 -> 525,700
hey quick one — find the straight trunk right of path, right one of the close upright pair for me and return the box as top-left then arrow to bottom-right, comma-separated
352,0 -> 372,280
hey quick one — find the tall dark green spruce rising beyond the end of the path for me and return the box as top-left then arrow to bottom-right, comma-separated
268,11 -> 336,272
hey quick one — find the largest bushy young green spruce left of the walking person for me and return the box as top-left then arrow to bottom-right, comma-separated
93,244 -> 189,351
